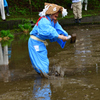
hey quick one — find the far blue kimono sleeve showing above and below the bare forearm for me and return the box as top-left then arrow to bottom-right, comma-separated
50,22 -> 68,48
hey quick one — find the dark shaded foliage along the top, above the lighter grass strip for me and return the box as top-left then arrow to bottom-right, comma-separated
7,0 -> 100,15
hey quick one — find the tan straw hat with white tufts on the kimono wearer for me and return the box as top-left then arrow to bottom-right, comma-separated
39,3 -> 68,17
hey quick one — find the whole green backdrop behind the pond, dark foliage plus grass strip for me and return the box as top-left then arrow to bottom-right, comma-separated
0,0 -> 100,22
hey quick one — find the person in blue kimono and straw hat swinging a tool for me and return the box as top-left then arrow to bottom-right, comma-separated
28,3 -> 71,78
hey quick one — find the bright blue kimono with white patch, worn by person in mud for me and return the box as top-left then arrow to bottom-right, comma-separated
28,15 -> 68,74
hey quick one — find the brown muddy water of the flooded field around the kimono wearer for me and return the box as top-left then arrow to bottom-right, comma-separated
0,25 -> 100,100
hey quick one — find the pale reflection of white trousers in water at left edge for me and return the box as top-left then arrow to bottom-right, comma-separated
0,43 -> 11,82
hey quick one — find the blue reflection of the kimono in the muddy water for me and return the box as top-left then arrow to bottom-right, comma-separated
33,79 -> 51,100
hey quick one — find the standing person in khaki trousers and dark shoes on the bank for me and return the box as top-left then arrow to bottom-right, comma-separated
72,0 -> 82,23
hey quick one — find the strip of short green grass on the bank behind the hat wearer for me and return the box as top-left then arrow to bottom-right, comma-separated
0,9 -> 100,23
